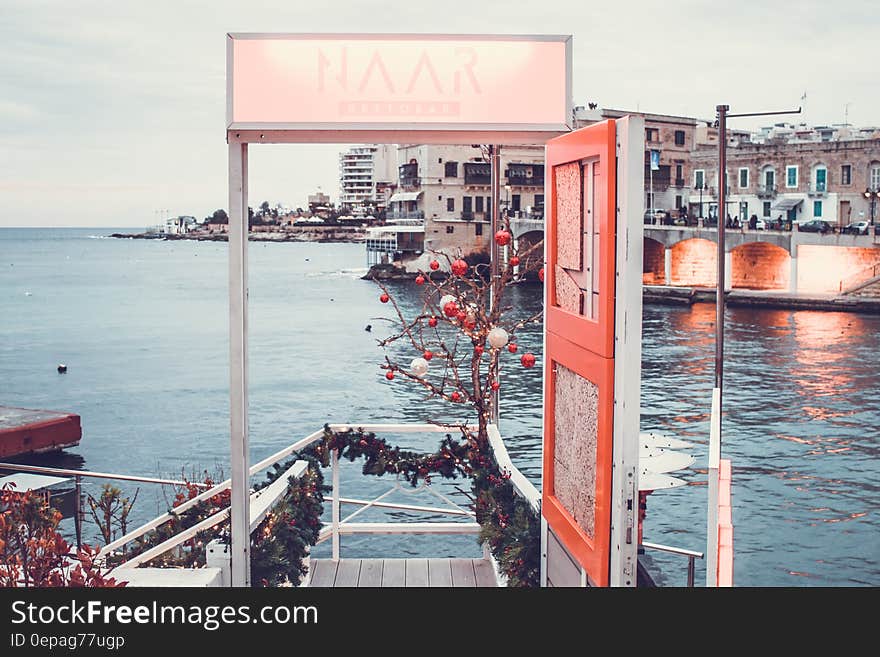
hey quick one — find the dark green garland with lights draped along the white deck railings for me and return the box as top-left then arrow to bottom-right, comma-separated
110,425 -> 541,587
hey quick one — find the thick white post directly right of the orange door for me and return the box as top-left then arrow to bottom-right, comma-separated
608,116 -> 645,587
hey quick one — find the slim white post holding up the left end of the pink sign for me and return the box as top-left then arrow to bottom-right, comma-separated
228,134 -> 251,587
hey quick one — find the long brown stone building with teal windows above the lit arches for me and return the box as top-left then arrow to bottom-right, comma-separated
688,123 -> 880,228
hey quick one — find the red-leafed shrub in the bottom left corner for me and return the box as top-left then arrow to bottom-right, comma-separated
0,485 -> 126,587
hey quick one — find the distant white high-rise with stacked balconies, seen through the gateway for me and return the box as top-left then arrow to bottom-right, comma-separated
339,144 -> 397,217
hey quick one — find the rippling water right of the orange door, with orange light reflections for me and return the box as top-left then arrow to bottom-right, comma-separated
642,305 -> 880,586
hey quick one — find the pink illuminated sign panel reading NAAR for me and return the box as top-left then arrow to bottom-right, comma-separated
227,34 -> 571,131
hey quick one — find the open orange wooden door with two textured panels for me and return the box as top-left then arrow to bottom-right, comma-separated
542,120 -> 616,586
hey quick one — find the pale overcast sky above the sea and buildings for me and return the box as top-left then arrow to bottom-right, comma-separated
0,0 -> 880,226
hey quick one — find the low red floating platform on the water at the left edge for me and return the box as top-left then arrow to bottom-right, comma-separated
0,406 -> 82,459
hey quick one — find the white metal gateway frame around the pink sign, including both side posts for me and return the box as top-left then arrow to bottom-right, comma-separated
226,34 -> 642,586
